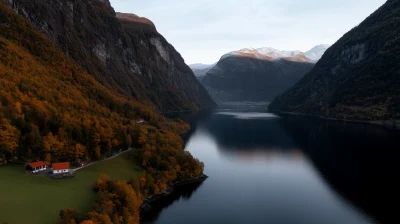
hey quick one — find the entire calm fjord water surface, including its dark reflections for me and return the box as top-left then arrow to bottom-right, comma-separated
147,107 -> 400,224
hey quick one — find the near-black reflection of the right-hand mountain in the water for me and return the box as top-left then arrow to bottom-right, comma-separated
283,116 -> 400,223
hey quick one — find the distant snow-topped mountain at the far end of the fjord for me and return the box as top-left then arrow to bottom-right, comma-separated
202,48 -> 314,103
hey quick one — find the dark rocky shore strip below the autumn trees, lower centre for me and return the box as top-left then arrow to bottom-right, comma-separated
139,174 -> 208,215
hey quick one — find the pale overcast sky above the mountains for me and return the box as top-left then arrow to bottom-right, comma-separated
110,0 -> 386,64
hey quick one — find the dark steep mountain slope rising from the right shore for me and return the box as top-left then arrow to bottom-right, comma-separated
269,0 -> 400,120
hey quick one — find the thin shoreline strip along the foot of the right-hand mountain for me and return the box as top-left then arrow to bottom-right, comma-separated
276,111 -> 400,130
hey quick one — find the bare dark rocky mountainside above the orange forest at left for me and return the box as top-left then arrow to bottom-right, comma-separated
0,0 -> 213,111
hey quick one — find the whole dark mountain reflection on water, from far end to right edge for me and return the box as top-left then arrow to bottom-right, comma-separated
166,109 -> 400,223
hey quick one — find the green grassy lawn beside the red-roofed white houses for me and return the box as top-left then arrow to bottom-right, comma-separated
0,152 -> 142,224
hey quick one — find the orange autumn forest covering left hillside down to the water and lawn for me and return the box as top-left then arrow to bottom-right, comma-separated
0,3 -> 204,223
